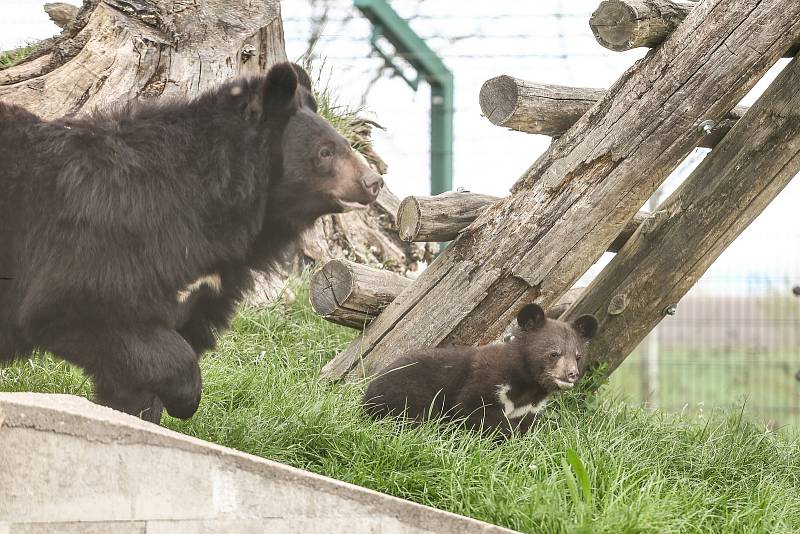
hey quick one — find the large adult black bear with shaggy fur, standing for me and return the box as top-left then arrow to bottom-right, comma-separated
0,63 -> 383,422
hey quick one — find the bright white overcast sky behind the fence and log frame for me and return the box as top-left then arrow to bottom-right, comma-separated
0,0 -> 800,294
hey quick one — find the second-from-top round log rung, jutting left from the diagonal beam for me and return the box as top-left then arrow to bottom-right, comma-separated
480,75 -> 747,148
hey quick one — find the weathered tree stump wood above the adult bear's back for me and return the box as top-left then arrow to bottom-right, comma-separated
0,0 -> 286,119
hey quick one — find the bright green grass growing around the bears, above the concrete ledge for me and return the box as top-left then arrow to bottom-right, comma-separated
0,278 -> 800,533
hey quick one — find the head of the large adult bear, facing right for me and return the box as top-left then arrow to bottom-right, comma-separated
259,63 -> 383,219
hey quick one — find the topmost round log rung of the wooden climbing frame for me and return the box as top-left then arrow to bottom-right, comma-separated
589,0 -> 800,57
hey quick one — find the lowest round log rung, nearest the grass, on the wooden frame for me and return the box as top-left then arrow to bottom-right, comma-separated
310,259 -> 411,329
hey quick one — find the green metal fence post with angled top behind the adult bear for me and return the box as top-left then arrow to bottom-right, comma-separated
353,0 -> 453,195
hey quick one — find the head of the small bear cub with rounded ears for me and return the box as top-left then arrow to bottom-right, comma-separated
514,304 -> 598,391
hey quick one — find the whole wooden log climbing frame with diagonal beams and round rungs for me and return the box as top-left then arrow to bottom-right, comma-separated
312,0 -> 800,386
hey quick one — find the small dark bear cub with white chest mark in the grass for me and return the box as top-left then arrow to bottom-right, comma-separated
363,304 -> 598,437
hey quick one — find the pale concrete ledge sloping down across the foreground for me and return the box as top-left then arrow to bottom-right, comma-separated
0,393 -> 512,534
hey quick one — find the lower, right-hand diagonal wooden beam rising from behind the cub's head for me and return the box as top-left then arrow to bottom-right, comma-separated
565,51 -> 800,371
